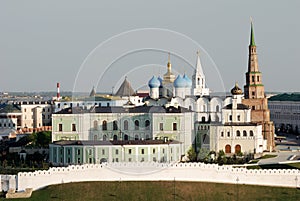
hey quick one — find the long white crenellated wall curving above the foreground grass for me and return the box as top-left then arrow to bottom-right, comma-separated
17,163 -> 300,191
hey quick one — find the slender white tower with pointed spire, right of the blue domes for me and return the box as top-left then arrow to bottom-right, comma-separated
193,51 -> 209,96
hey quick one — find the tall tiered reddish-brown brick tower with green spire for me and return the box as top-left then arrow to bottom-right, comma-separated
242,22 -> 275,151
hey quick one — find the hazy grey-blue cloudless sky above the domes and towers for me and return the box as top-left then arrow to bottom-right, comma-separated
0,0 -> 300,92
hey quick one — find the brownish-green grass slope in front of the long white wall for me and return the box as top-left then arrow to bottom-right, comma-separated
5,181 -> 300,201
